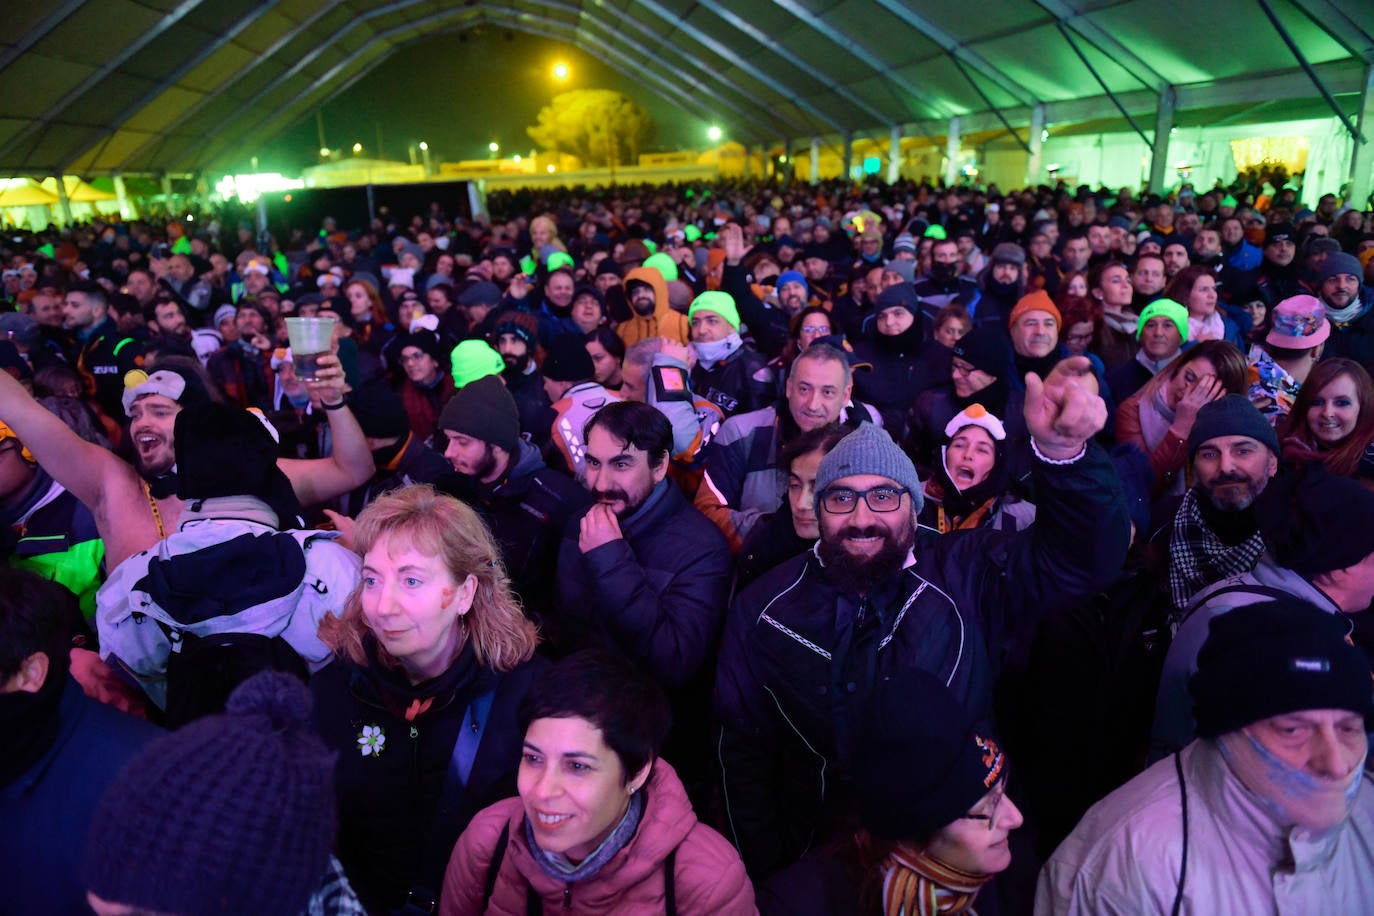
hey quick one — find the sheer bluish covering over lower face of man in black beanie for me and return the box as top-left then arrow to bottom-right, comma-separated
1217,729 -> 1364,829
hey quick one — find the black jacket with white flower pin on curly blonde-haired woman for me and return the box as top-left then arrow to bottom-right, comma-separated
311,639 -> 547,912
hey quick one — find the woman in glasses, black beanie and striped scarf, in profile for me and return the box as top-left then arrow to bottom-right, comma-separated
758,669 -> 1022,916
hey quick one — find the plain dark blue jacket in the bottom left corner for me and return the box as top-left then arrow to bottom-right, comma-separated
0,677 -> 162,916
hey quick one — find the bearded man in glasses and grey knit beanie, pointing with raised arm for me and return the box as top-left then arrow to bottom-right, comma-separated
716,357 -> 1129,878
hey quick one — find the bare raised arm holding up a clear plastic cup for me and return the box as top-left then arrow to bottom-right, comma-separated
276,353 -> 376,505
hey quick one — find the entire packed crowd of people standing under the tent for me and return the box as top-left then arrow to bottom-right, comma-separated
0,173 -> 1374,916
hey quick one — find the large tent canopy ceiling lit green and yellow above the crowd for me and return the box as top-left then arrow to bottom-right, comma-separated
0,0 -> 1374,174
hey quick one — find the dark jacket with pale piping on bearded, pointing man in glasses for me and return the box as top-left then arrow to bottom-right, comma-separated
716,445 -> 1129,878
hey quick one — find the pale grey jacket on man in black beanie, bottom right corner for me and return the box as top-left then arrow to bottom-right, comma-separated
1035,740 -> 1374,916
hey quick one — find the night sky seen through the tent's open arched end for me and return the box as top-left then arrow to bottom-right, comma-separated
262,26 -> 710,174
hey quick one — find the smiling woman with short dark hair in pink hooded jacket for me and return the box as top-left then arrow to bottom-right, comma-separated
440,651 -> 757,916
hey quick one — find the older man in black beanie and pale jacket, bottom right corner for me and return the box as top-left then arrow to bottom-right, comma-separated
1035,596 -> 1374,916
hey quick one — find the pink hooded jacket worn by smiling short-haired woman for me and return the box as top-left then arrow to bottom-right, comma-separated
438,759 -> 758,916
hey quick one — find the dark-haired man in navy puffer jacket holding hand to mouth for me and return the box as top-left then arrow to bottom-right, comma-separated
545,401 -> 732,803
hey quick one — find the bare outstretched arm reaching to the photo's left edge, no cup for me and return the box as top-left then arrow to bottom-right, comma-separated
0,362 -> 133,512
